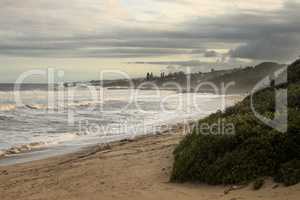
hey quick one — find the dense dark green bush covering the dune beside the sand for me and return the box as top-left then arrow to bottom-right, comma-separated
171,61 -> 300,185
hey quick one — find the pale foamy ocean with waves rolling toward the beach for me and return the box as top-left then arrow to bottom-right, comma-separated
0,84 -> 241,164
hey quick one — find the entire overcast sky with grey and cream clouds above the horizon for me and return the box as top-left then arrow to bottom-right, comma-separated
0,0 -> 300,83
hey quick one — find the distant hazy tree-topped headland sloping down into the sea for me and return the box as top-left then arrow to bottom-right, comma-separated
69,62 -> 284,94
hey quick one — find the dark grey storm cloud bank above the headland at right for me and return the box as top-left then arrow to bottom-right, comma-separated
122,1 -> 300,61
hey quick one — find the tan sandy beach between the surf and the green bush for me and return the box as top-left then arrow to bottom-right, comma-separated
0,128 -> 300,200
